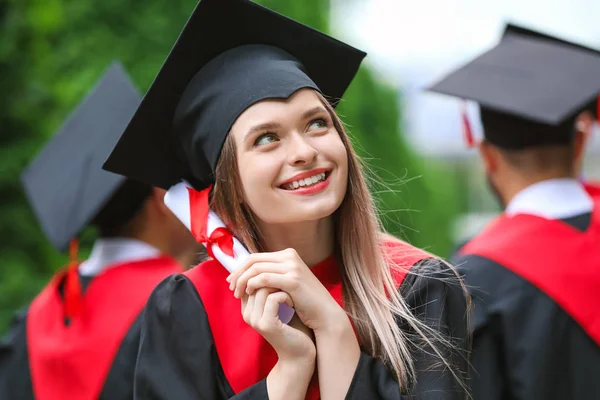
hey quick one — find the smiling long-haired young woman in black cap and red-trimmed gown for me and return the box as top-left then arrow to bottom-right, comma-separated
105,0 -> 468,400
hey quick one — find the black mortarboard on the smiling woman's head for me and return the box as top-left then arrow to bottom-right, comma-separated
104,0 -> 365,190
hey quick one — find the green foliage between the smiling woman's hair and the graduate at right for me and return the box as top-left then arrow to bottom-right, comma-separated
338,68 -> 458,256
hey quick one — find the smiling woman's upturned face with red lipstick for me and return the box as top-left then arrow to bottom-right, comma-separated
231,89 -> 348,224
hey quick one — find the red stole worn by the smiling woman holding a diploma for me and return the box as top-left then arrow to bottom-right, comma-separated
185,242 -> 431,400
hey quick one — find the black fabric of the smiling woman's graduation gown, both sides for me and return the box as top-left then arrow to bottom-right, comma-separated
134,252 -> 468,400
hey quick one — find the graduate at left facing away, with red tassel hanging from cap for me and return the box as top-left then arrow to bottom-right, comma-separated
0,63 -> 198,400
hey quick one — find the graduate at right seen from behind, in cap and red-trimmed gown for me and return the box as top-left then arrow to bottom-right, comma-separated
430,26 -> 600,400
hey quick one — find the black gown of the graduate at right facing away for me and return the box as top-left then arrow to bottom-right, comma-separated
453,214 -> 600,400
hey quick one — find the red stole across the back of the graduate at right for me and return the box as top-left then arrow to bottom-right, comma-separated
461,198 -> 600,344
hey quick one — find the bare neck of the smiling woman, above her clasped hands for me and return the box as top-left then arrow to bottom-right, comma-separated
259,217 -> 335,267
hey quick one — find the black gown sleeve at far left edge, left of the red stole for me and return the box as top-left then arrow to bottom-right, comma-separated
0,309 -> 33,400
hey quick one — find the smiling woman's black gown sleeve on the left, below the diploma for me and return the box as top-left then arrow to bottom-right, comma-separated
134,275 -> 268,400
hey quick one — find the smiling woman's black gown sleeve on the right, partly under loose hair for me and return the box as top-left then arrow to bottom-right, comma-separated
346,259 -> 469,400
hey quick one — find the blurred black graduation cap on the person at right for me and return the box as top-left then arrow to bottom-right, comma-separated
428,30 -> 600,149
